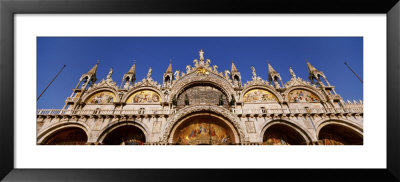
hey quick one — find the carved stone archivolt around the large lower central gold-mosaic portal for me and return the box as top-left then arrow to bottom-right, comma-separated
162,106 -> 248,143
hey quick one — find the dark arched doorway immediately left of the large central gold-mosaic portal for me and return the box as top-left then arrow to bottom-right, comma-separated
102,125 -> 146,145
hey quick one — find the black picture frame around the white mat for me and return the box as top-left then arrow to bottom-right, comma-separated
0,0 -> 400,181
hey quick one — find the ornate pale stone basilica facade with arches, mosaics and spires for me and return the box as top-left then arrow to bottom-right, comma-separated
37,50 -> 363,145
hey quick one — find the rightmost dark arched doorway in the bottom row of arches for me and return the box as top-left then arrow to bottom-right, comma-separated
318,124 -> 363,145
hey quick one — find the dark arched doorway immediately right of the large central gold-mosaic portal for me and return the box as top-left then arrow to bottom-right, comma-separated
263,124 -> 307,145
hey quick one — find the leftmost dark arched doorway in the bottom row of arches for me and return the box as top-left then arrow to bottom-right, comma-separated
43,127 -> 88,145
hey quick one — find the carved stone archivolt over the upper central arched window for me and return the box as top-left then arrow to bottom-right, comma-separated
169,72 -> 235,102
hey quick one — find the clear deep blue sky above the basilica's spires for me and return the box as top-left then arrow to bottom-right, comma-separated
37,37 -> 363,109
